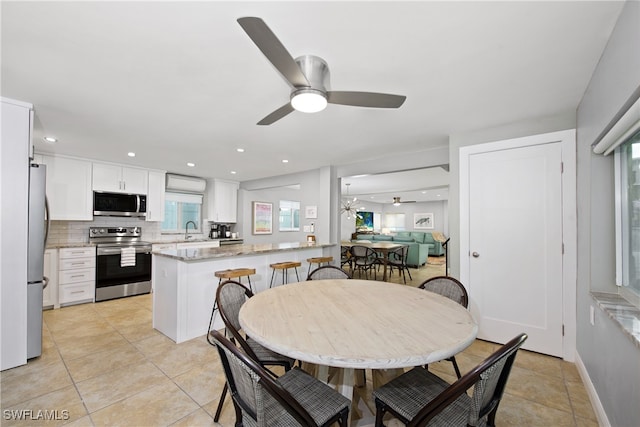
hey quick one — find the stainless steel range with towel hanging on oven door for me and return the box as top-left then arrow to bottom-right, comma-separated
89,227 -> 151,302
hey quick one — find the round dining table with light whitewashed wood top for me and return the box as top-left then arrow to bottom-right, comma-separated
240,279 -> 478,412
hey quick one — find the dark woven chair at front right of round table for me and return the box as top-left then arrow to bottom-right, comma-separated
373,334 -> 527,427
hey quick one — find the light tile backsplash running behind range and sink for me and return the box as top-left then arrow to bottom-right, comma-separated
47,216 -> 208,246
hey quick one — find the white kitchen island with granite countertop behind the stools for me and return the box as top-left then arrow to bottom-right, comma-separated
151,242 -> 335,343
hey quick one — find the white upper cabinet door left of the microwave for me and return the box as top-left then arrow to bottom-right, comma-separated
42,155 -> 93,221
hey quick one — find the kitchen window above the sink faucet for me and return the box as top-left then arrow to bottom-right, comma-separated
162,193 -> 202,233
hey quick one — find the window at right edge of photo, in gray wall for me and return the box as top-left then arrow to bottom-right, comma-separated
615,132 -> 640,295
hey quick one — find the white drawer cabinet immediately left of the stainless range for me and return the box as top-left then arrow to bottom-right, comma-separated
58,247 -> 96,306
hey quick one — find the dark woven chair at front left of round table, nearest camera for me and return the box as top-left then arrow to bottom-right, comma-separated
211,330 -> 351,427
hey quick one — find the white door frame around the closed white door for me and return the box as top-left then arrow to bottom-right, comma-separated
458,129 -> 578,362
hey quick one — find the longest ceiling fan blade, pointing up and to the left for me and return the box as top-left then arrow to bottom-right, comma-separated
238,16 -> 311,87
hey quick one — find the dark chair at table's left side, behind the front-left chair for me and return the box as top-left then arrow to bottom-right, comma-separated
207,280 -> 295,422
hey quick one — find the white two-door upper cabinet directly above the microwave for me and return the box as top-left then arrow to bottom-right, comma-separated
93,163 -> 149,194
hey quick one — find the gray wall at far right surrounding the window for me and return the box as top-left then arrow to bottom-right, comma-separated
577,1 -> 640,426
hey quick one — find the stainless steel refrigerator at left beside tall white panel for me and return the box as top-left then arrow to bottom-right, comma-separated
27,164 -> 49,359
